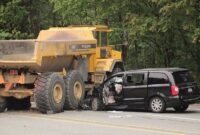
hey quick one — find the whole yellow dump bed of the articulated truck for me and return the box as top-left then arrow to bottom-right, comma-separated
0,30 -> 96,72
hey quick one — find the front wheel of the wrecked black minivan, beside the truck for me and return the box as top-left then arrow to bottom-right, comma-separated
91,98 -> 104,111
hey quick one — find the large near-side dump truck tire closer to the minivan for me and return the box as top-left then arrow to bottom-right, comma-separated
64,70 -> 85,110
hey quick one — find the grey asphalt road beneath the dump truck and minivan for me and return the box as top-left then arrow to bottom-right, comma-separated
0,105 -> 200,135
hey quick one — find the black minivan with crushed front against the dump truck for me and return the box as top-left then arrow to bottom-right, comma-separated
91,68 -> 200,112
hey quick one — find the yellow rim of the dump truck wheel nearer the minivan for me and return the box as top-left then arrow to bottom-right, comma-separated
74,81 -> 83,100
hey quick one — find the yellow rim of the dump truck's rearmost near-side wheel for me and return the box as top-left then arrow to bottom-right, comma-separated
53,84 -> 63,103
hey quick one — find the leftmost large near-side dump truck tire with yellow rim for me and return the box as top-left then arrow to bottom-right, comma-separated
34,73 -> 65,113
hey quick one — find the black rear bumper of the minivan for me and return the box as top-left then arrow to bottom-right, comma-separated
166,96 -> 200,107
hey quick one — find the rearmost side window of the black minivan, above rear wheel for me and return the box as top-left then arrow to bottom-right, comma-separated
148,73 -> 169,84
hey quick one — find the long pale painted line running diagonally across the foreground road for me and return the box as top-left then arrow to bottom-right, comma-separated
1,113 -> 187,135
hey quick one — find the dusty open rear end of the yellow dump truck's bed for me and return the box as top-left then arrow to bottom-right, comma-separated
0,40 -> 36,68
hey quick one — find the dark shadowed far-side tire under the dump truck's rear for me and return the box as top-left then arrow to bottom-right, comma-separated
7,97 -> 31,110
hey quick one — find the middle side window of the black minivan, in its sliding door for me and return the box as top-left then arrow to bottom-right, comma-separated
126,73 -> 144,86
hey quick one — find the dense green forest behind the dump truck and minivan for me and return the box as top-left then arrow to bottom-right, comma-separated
0,0 -> 200,81
